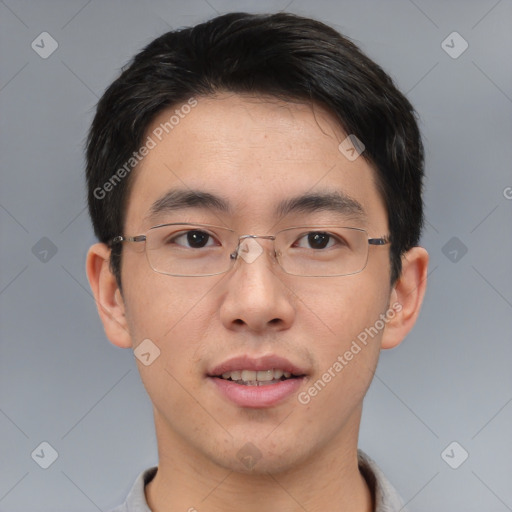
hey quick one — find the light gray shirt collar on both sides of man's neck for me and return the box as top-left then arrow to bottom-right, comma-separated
110,450 -> 407,512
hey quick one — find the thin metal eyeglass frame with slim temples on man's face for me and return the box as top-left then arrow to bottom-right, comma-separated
108,222 -> 391,277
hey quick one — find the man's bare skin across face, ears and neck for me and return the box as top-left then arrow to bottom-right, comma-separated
87,93 -> 428,512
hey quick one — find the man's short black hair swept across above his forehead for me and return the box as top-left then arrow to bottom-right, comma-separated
86,12 -> 424,286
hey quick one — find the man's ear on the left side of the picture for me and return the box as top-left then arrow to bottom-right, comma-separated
86,244 -> 132,348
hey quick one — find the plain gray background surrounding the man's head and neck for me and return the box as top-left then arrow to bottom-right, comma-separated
0,0 -> 512,512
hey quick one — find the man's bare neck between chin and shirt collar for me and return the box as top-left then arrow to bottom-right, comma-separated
145,413 -> 374,512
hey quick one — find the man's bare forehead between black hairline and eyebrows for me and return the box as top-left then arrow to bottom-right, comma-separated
125,93 -> 386,229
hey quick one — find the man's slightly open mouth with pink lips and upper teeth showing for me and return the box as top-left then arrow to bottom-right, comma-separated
207,355 -> 307,408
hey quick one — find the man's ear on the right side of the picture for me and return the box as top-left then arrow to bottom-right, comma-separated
381,247 -> 428,349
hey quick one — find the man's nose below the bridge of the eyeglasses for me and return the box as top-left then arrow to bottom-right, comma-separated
220,236 -> 295,333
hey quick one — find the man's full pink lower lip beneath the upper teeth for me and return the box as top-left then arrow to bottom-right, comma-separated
209,377 -> 303,408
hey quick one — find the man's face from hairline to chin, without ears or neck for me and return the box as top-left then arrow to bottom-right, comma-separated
121,94 -> 391,472
